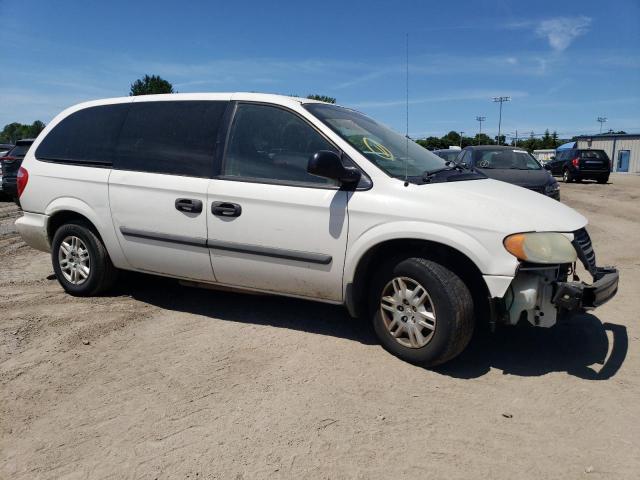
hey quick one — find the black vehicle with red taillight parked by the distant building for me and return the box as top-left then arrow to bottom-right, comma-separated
547,148 -> 611,183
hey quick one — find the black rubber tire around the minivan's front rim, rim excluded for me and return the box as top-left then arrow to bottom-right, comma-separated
369,258 -> 475,367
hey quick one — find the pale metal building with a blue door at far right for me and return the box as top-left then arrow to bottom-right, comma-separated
576,133 -> 640,173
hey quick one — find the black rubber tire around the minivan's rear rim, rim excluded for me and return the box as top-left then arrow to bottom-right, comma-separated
51,220 -> 118,297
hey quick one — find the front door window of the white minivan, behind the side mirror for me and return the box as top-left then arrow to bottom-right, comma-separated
222,104 -> 336,185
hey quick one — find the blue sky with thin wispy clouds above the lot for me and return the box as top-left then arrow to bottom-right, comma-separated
0,0 -> 640,141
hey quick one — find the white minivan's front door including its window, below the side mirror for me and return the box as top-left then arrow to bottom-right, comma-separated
207,103 -> 351,302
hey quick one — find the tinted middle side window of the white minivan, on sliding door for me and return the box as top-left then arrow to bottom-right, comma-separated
113,100 -> 228,178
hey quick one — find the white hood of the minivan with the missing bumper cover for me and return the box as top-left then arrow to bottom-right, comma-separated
394,178 -> 587,235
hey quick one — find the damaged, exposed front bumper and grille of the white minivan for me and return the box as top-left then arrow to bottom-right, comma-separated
492,228 -> 619,327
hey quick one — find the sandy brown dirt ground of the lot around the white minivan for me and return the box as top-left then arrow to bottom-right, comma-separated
0,176 -> 640,479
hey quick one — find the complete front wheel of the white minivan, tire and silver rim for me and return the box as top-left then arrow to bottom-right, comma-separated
371,258 -> 474,367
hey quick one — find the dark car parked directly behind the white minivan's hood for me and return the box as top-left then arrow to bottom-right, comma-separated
457,145 -> 560,200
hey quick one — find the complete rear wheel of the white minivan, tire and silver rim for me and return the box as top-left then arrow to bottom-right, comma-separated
51,221 -> 118,297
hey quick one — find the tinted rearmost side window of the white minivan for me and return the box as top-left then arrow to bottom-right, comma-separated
36,103 -> 129,166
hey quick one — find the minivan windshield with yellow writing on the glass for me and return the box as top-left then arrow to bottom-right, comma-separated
304,103 -> 445,178
